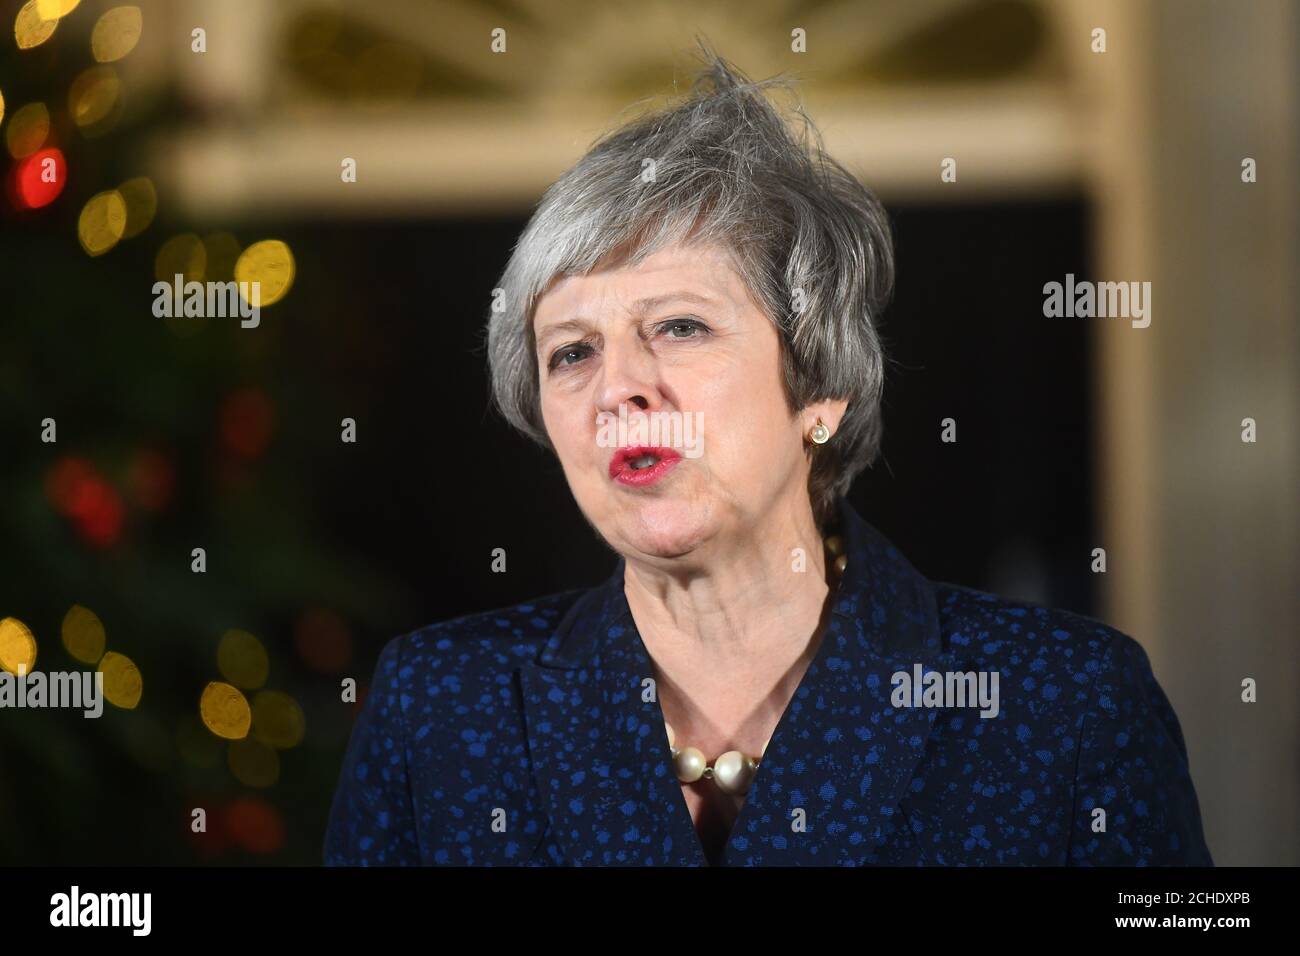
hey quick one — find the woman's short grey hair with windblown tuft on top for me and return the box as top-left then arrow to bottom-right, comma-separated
488,44 -> 893,524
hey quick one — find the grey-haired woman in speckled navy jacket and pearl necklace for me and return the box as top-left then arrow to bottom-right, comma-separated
325,48 -> 1210,866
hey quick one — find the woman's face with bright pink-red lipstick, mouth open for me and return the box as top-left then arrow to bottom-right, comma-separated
533,246 -> 833,559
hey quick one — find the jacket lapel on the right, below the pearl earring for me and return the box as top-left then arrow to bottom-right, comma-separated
725,502 -> 950,866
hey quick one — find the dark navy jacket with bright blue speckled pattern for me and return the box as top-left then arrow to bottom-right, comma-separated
325,501 -> 1213,866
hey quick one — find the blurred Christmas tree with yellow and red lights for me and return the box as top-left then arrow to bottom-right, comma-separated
0,0 -> 412,864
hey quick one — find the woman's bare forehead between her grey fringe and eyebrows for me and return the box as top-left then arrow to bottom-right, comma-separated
533,245 -> 748,334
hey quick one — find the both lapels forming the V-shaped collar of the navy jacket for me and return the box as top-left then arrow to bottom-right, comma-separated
520,499 -> 949,866
